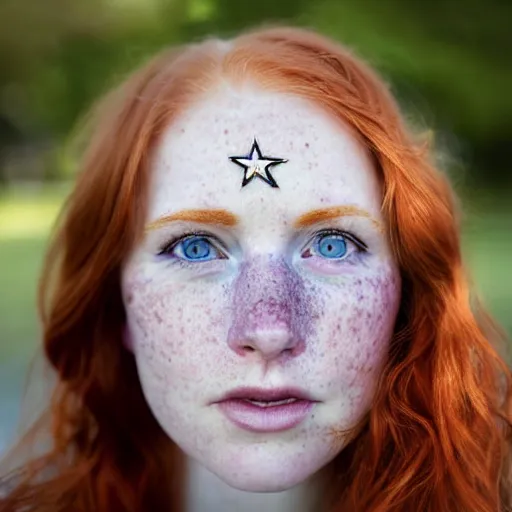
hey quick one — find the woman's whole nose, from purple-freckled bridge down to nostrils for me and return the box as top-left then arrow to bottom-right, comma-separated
228,257 -> 307,360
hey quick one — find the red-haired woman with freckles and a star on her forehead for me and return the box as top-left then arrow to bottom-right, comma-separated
0,29 -> 511,512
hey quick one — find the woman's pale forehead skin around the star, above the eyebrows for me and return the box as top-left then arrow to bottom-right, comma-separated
149,87 -> 380,220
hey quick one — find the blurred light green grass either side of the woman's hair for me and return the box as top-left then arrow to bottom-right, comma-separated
0,187 -> 512,360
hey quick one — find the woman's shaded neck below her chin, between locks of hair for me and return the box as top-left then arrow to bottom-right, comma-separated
186,459 -> 321,512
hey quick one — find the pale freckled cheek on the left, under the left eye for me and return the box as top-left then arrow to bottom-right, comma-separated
125,276 -> 227,383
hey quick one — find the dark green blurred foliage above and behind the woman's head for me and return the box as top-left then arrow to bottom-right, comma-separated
0,0 -> 512,184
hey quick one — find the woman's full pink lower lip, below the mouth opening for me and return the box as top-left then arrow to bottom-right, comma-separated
219,399 -> 314,432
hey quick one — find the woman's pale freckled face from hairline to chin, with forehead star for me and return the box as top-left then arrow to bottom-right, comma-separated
123,88 -> 400,491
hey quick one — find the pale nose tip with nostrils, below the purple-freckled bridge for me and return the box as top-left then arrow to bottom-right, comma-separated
231,325 -> 299,361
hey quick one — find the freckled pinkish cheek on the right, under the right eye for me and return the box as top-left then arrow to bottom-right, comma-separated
308,269 -> 400,390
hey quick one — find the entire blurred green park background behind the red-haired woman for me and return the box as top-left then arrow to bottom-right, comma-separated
0,0 -> 512,452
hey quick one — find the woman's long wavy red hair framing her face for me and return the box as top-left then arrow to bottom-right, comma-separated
0,29 -> 512,512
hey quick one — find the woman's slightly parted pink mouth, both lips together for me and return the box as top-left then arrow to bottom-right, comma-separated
216,388 -> 317,433
